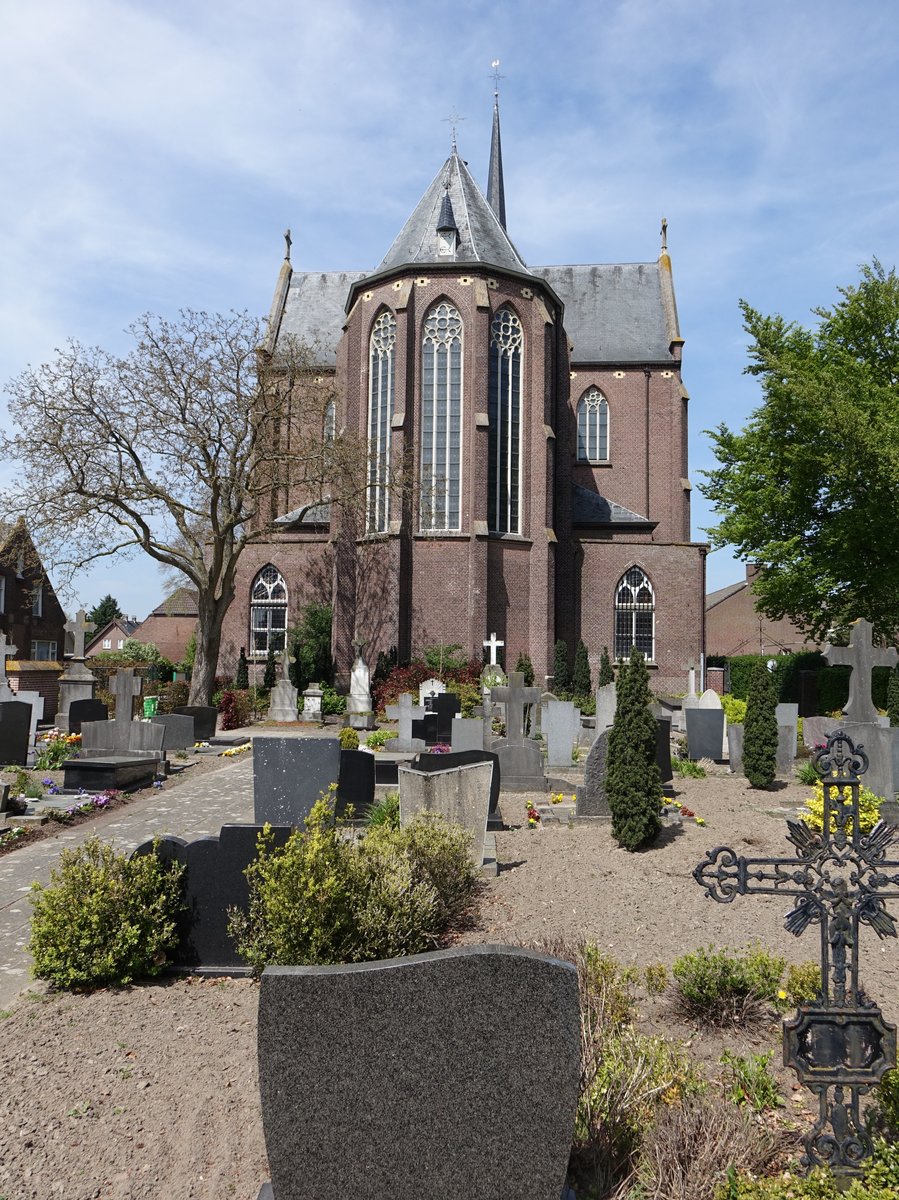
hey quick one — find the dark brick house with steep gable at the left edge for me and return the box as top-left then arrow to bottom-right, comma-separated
0,518 -> 66,720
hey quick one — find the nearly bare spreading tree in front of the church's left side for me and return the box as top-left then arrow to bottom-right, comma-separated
0,311 -> 366,703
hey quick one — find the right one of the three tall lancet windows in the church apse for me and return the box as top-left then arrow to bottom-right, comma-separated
487,308 -> 523,533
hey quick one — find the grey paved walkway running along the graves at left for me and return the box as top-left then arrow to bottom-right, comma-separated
0,728 -> 262,1008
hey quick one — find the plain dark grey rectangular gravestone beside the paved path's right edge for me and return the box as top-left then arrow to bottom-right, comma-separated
253,737 -> 340,828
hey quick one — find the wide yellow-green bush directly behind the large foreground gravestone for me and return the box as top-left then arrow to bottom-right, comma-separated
229,797 -> 477,973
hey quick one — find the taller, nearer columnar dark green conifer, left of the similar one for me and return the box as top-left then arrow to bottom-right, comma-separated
606,647 -> 661,850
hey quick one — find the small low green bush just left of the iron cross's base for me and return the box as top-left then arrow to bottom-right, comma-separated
671,944 -> 786,1025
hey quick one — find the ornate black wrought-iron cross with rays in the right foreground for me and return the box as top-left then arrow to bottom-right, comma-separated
693,730 -> 899,1176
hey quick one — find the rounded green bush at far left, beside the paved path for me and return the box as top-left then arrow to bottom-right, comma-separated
28,838 -> 184,988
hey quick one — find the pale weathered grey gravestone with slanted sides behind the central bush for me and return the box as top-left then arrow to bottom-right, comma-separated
397,755 -> 493,869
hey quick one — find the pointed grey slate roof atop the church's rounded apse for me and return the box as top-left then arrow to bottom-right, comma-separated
374,150 -> 531,275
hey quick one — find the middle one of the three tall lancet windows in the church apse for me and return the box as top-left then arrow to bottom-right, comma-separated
421,302 -> 462,529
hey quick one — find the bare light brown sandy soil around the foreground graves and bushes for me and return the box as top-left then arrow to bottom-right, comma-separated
0,776 -> 899,1200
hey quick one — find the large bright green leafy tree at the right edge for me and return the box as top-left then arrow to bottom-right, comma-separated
702,260 -> 899,642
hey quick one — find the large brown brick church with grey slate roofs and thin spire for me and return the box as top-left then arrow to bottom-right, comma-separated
222,104 -> 706,691
